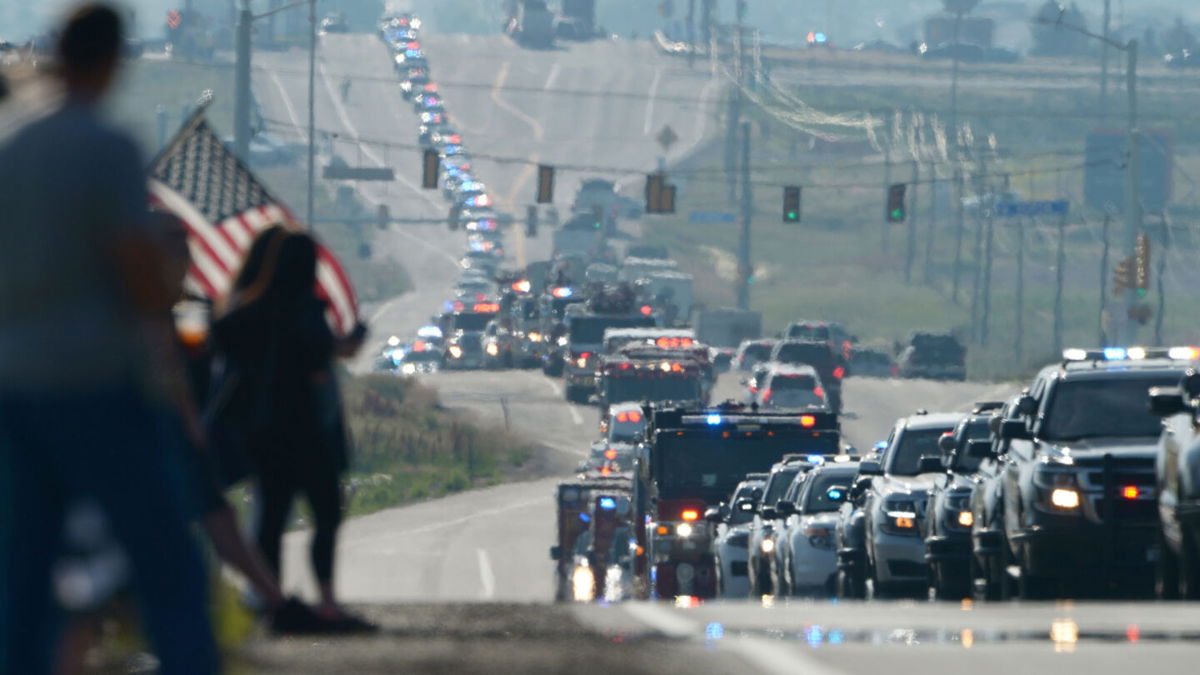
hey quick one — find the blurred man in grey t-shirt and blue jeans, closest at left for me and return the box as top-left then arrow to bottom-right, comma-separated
0,5 -> 218,675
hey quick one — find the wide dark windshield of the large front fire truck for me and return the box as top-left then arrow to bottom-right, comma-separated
652,431 -> 838,504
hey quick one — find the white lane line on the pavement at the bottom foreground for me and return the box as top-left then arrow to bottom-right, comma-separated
622,602 -> 841,675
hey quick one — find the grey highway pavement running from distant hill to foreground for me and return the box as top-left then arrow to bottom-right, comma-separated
243,23 -> 1200,674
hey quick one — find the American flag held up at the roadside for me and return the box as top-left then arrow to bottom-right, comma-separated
149,107 -> 358,334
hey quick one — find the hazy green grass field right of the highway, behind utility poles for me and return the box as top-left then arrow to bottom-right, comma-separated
643,70 -> 1200,378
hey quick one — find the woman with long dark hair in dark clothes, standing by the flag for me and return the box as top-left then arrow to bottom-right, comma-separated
212,227 -> 371,631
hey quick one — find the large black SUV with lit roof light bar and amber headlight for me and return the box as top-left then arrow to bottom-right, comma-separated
982,348 -> 1188,598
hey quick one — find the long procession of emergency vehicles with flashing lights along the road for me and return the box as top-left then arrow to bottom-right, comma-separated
377,6 -> 1200,602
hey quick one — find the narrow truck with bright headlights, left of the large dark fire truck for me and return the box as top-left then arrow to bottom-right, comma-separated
550,476 -> 638,602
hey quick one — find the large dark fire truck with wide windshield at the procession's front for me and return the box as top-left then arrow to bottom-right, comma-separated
634,401 -> 842,598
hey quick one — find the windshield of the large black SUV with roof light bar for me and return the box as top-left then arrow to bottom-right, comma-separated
1040,371 -> 1181,441
